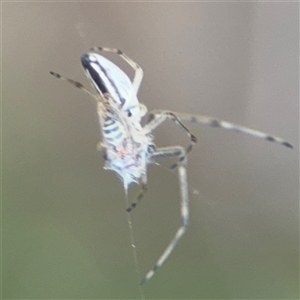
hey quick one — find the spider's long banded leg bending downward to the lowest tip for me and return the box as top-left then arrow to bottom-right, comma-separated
140,146 -> 189,285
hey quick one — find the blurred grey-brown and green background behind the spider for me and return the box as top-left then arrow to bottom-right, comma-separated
2,2 -> 299,299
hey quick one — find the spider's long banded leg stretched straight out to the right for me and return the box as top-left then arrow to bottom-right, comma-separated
152,110 -> 293,149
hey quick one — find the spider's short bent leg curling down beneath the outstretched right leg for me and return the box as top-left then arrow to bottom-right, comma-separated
144,110 -> 197,169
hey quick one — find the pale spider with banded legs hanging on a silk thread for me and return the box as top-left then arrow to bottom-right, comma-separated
50,47 -> 293,285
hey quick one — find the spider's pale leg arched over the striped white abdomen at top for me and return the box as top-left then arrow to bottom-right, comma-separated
90,47 -> 144,95
